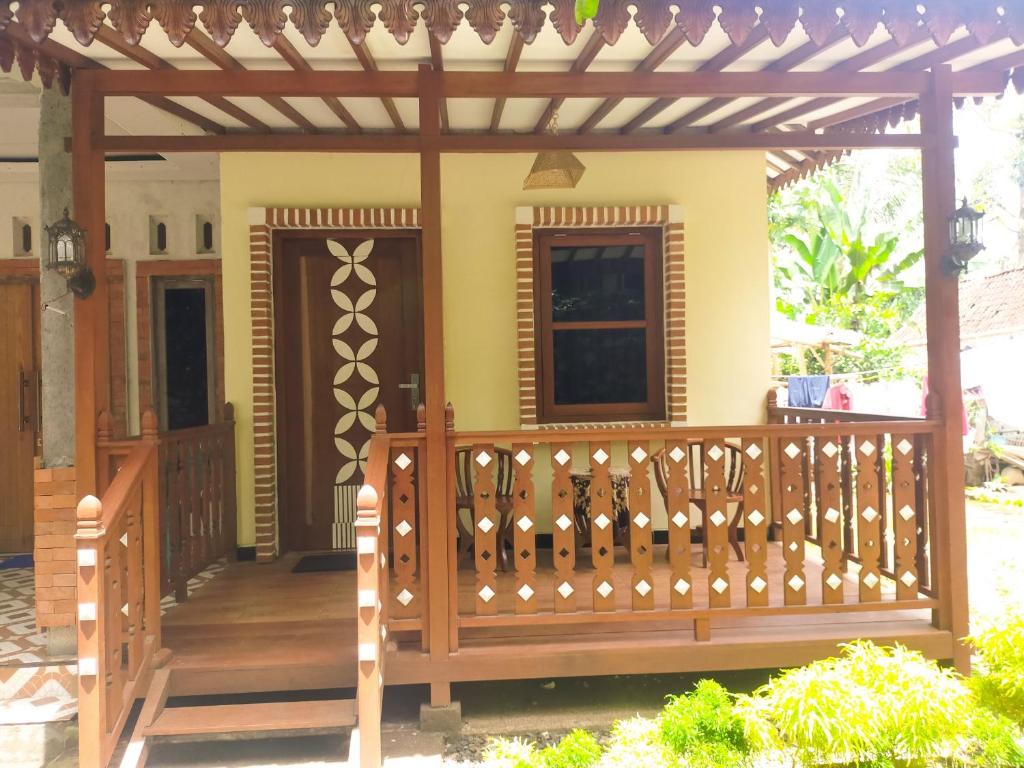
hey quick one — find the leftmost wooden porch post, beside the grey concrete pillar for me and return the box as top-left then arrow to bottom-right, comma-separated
72,70 -> 110,497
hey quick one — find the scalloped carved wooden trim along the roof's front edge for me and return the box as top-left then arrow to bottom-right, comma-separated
0,0 -> 1024,52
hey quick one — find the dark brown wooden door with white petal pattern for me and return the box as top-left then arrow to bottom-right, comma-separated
273,229 -> 423,551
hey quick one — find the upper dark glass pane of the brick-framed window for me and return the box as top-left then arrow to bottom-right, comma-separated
551,245 -> 644,323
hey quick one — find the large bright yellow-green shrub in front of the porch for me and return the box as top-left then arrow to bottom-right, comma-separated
738,642 -> 974,768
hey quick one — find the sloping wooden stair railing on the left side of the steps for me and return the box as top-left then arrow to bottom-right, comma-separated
75,412 -> 161,766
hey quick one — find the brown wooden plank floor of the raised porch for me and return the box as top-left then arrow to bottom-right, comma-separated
163,545 -> 952,693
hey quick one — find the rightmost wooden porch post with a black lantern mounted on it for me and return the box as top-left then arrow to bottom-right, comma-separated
921,65 -> 971,673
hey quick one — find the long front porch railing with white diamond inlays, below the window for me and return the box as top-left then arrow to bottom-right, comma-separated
447,409 -> 938,640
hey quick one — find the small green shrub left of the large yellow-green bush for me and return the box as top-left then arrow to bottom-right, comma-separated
660,680 -> 750,768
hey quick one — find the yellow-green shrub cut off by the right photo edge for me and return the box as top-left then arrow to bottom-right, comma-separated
970,611 -> 1024,724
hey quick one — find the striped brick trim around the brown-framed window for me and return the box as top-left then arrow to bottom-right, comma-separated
515,205 -> 686,427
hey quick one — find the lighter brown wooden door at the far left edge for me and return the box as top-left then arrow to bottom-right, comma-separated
0,282 -> 39,552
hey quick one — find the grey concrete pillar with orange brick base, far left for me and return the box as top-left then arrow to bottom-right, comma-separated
36,88 -> 76,656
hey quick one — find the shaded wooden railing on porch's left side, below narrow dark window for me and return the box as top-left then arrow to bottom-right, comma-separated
96,402 -> 237,602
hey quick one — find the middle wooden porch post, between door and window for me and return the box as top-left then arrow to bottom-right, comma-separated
419,65 -> 453,707
